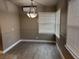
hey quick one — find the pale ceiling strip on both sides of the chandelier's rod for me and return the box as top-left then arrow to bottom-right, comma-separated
12,0 -> 58,6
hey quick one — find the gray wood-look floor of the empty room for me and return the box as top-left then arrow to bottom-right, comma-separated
0,42 -> 62,59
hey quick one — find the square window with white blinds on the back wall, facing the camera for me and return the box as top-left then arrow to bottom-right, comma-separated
38,12 -> 55,34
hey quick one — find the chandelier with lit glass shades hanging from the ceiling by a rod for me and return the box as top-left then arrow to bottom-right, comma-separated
23,0 -> 38,18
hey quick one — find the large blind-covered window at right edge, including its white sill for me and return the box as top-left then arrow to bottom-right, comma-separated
66,0 -> 79,59
